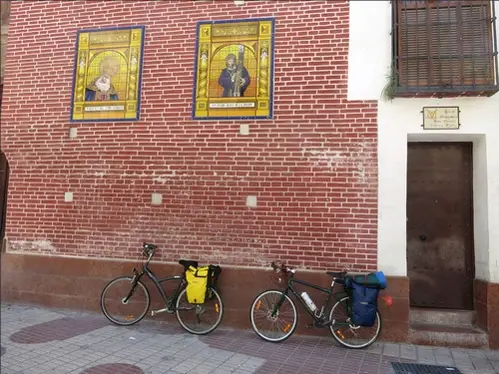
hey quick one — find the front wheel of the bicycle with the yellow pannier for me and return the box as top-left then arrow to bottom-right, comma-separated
100,276 -> 151,326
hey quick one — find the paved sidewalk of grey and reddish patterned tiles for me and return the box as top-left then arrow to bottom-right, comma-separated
1,303 -> 499,374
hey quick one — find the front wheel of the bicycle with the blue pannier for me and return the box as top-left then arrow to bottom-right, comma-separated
250,290 -> 298,342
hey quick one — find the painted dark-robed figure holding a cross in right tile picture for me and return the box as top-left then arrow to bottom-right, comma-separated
218,46 -> 251,97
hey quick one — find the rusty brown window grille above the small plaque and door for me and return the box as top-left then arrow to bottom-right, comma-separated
393,0 -> 499,94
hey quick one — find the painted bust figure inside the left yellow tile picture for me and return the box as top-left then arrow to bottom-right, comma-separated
85,56 -> 120,101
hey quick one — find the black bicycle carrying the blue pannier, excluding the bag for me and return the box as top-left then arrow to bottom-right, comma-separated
250,262 -> 381,348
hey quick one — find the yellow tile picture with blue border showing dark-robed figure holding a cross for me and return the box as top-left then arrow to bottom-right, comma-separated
193,18 -> 275,119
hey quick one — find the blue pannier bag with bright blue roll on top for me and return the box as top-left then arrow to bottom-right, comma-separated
345,272 -> 386,327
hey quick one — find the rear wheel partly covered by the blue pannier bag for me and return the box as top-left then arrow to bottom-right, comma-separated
329,296 -> 381,349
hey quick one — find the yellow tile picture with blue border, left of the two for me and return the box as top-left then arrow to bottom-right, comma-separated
71,26 -> 144,122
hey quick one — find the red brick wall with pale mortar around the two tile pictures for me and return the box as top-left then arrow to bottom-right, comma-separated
1,0 -> 377,269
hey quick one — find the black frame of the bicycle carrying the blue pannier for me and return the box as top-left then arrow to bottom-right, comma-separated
272,275 -> 348,327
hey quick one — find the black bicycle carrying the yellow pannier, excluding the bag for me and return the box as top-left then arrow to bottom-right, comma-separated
100,243 -> 224,335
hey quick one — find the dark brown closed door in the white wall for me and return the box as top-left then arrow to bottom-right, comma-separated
407,143 -> 475,309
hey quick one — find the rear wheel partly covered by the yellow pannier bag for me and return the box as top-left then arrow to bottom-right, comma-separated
175,287 -> 224,335
